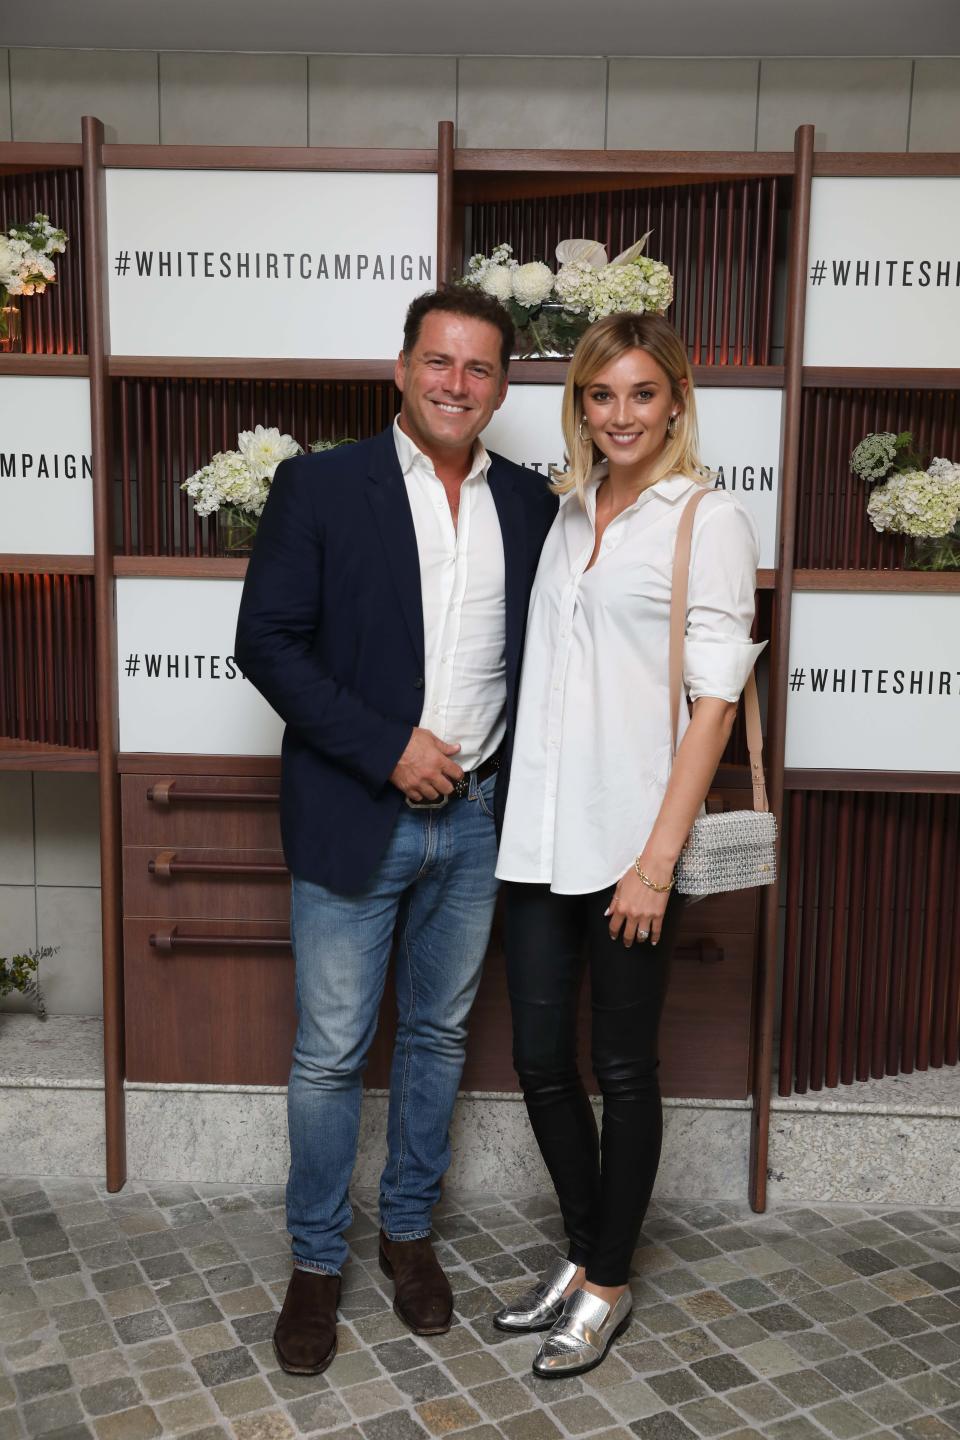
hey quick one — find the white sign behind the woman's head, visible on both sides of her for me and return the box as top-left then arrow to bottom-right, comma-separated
484,384 -> 783,569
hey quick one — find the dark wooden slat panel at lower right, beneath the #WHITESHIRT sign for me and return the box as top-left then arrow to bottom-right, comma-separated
780,791 -> 960,1094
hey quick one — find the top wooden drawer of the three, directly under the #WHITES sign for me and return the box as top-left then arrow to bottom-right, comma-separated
121,772 -> 281,850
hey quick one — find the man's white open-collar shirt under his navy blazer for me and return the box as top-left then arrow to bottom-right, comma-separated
393,420 -> 507,770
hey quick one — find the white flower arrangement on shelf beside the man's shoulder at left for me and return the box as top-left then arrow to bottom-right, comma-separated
180,425 -> 353,550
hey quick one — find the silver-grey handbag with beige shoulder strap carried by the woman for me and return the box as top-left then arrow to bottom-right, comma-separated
669,490 -> 777,896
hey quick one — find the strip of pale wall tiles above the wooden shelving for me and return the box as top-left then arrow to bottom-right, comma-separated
0,49 -> 960,151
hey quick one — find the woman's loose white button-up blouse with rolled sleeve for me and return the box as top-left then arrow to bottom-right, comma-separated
497,467 -> 763,894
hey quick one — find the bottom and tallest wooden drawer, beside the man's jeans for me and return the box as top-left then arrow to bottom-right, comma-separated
124,919 -> 296,1084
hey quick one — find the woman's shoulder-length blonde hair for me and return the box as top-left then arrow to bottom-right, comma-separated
551,314 -> 707,504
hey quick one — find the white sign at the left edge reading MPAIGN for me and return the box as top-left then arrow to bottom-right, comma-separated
0,374 -> 94,554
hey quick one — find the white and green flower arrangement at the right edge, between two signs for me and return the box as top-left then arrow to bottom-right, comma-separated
851,431 -> 960,570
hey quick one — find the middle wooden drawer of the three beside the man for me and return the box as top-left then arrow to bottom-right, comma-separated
124,845 -> 289,923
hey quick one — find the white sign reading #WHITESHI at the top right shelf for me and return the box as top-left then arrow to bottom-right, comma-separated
803,177 -> 960,369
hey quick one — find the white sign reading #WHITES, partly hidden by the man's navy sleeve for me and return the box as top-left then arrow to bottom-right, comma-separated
117,579 -> 284,755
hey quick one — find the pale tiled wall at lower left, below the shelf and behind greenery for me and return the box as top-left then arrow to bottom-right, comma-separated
0,772 -> 102,1015
